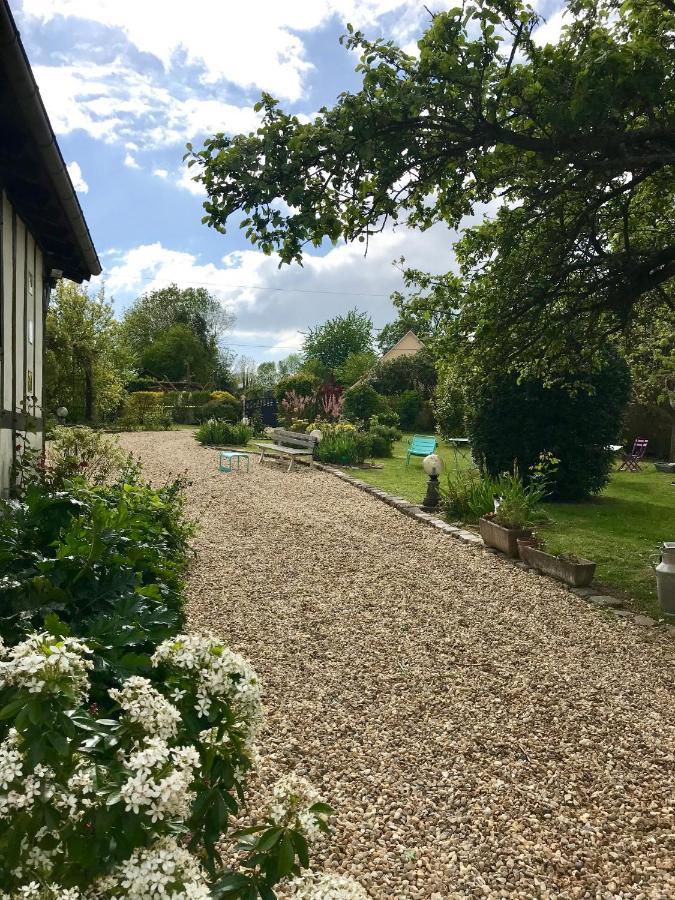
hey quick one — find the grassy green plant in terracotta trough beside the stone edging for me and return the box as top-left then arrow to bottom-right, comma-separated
478,471 -> 544,559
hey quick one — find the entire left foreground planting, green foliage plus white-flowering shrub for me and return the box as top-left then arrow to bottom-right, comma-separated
0,450 -> 359,900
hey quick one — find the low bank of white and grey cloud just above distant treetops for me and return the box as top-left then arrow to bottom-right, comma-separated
104,218 -> 454,359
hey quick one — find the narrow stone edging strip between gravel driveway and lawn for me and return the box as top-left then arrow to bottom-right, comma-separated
313,462 -> 675,638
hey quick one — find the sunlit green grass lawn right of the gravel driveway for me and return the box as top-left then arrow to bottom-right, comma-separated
340,435 -> 675,614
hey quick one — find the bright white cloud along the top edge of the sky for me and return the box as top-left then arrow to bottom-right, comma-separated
23,0 -> 460,100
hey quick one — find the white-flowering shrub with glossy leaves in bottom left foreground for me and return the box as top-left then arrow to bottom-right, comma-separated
0,632 -> 344,900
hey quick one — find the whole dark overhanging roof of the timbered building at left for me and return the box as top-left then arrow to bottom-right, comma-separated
0,0 -> 101,282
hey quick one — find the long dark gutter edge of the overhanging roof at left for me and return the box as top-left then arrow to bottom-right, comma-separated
0,0 -> 101,280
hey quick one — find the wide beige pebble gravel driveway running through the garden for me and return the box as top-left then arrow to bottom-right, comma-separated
121,431 -> 675,900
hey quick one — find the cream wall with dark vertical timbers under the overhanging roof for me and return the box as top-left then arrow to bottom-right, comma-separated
0,191 -> 44,494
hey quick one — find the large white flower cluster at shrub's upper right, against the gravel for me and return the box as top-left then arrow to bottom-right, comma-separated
152,634 -> 262,743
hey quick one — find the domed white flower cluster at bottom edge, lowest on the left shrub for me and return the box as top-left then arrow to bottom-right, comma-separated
95,837 -> 211,900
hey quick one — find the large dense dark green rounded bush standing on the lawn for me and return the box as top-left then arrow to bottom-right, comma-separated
468,354 -> 630,500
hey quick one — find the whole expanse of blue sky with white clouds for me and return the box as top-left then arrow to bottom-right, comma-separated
10,0 -> 561,361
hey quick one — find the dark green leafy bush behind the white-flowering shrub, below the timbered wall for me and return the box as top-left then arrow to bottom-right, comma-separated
0,477 -> 190,686
